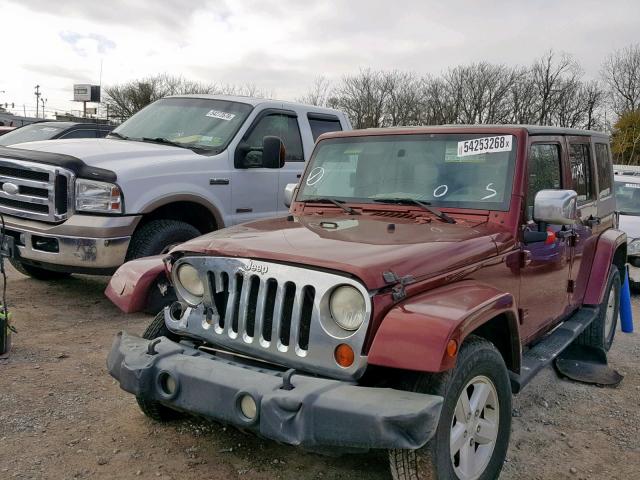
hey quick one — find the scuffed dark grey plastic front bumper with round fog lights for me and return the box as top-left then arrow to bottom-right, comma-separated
107,332 -> 442,450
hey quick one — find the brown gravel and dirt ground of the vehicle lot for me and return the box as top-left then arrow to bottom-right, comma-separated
0,270 -> 640,480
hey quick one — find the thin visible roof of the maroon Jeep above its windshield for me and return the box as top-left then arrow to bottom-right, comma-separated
320,124 -> 609,141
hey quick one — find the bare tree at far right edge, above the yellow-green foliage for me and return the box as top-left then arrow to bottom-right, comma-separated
602,44 -> 640,116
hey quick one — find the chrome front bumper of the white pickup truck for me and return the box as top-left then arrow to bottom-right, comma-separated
4,215 -> 140,273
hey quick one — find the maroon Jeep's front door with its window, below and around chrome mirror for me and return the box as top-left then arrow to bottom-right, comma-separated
520,137 -> 571,339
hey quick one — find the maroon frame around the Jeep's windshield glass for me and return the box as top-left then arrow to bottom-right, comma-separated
295,133 -> 521,212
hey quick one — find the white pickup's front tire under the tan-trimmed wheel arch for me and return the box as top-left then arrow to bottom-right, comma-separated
125,220 -> 201,261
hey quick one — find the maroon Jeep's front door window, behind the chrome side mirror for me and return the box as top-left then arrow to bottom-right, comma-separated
527,143 -> 562,220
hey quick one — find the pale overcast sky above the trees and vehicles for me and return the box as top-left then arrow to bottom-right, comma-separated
0,0 -> 640,117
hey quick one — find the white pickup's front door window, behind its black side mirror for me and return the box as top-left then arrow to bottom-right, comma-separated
244,113 -> 304,167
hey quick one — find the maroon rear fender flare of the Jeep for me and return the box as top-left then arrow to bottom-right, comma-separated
583,229 -> 627,305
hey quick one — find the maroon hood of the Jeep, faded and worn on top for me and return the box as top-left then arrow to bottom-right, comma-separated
172,215 -> 508,289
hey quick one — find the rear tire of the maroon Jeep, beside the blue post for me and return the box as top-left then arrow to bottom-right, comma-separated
576,265 -> 622,352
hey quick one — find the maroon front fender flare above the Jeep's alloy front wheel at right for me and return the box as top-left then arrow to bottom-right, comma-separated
368,280 -> 521,373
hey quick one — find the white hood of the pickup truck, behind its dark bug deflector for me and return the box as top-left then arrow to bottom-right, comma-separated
12,138 -> 201,172
